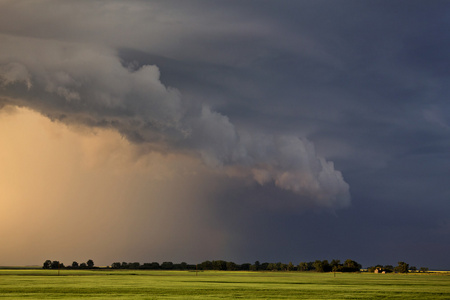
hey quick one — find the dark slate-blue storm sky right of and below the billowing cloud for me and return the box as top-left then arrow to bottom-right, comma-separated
127,1 -> 450,268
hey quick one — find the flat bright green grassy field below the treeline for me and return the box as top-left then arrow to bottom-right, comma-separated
0,270 -> 450,299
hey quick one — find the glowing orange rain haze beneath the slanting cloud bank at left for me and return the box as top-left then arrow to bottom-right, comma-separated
0,109 -> 232,265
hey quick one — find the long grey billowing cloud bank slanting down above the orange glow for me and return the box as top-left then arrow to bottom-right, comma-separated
0,31 -> 350,207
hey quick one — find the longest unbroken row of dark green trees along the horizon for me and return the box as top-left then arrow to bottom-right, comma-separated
111,259 -> 361,272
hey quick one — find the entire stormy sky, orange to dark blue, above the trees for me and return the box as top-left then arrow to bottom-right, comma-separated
0,0 -> 450,269
